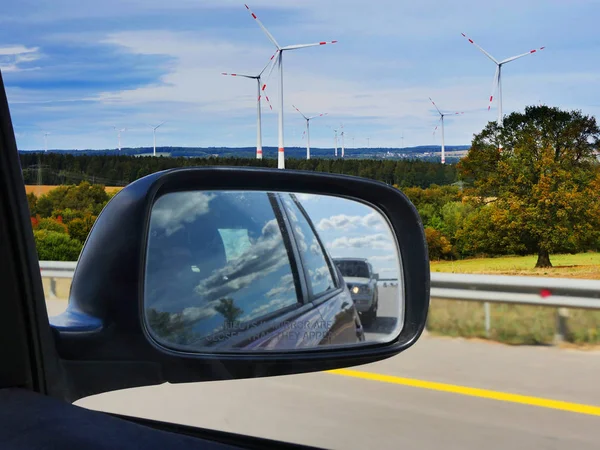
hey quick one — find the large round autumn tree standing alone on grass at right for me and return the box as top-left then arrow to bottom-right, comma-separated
458,106 -> 600,267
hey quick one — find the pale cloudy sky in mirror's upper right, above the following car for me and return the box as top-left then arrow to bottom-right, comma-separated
297,194 -> 399,278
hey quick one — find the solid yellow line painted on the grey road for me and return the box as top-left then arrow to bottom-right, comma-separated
328,369 -> 600,416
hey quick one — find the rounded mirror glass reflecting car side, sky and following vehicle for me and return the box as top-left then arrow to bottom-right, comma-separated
144,191 -> 404,353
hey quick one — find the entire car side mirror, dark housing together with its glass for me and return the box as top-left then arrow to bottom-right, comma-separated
50,167 -> 429,400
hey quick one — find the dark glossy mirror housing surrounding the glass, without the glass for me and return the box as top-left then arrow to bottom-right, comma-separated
50,167 -> 429,401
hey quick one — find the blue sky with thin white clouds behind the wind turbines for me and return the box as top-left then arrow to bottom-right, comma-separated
0,0 -> 600,149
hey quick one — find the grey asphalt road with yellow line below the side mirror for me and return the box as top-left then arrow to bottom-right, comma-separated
43,301 -> 600,450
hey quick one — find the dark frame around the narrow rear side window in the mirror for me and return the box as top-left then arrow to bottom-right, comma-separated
280,193 -> 344,304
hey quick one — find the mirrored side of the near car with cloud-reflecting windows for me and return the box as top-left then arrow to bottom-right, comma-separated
145,191 -> 364,350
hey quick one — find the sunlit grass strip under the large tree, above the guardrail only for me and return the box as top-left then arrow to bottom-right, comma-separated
431,252 -> 600,280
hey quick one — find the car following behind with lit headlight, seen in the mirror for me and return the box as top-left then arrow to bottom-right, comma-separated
334,258 -> 379,326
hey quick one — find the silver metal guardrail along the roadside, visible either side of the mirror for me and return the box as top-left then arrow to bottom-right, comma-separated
40,261 -> 600,340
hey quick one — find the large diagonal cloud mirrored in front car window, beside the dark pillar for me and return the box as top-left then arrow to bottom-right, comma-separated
195,219 -> 289,302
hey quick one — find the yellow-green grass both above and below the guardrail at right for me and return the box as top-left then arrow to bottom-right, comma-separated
428,252 -> 600,345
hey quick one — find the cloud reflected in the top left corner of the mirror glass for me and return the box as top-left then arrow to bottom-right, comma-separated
151,192 -> 215,236
